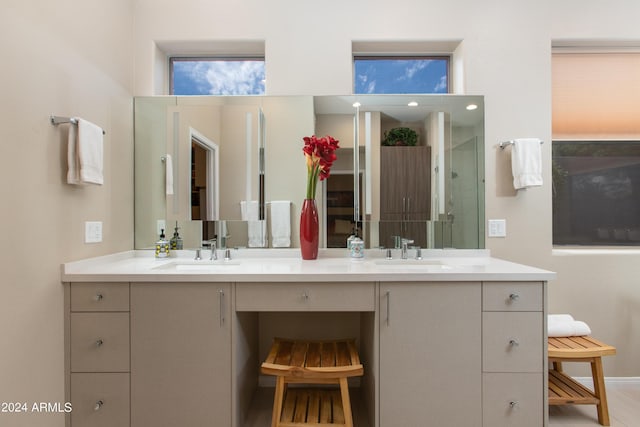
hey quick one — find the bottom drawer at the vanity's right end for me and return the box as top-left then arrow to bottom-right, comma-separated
482,373 -> 546,427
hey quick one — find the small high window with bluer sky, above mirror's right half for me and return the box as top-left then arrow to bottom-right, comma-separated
353,56 -> 449,94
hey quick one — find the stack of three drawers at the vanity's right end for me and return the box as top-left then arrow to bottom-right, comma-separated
482,282 -> 547,427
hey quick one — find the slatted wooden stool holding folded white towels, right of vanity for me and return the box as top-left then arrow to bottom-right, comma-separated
548,336 -> 616,426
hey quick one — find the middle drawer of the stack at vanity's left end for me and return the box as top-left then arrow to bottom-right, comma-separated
70,313 -> 129,372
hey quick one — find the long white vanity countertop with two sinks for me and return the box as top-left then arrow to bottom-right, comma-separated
61,249 -> 555,282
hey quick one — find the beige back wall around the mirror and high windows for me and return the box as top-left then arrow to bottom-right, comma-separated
135,0 -> 640,376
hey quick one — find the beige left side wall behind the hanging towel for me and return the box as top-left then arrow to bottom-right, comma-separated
0,0 -> 133,427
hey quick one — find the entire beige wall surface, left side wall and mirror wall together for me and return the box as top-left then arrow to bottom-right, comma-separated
0,0 -> 640,426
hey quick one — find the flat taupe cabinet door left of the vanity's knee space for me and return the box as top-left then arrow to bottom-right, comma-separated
131,283 -> 231,427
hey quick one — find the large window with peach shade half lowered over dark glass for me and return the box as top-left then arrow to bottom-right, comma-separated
552,52 -> 640,246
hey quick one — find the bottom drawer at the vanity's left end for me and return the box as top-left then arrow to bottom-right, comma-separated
71,373 -> 130,427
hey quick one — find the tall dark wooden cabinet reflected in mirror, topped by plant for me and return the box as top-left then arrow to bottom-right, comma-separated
380,146 -> 431,247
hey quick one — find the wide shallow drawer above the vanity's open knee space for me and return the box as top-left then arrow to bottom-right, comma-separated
236,282 -> 375,311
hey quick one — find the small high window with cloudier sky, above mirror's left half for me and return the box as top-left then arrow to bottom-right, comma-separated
170,57 -> 265,95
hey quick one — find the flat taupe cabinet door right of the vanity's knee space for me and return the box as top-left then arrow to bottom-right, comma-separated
380,282 -> 482,427
